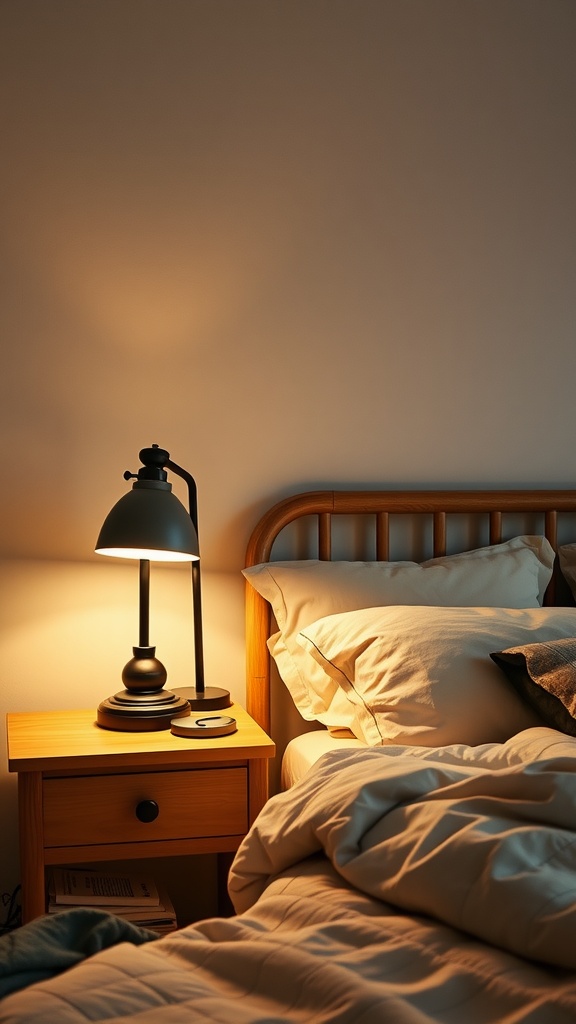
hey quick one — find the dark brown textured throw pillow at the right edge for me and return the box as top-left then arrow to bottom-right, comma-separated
490,637 -> 576,736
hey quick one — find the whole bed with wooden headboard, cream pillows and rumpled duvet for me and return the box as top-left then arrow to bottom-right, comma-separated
0,490 -> 576,1024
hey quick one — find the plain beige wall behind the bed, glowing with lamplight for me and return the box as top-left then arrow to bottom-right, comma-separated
0,0 -> 576,905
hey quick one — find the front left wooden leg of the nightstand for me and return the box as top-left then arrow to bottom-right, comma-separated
18,771 -> 46,925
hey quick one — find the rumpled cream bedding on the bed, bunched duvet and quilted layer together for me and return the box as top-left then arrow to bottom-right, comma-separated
0,729 -> 576,1024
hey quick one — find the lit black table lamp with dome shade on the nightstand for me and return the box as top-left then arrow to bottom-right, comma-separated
96,444 -> 231,732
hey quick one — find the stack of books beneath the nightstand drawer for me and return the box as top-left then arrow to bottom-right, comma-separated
48,867 -> 177,935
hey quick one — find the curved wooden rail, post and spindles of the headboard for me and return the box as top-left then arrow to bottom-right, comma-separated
246,489 -> 576,731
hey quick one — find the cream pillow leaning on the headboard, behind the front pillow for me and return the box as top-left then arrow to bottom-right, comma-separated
243,537 -> 554,727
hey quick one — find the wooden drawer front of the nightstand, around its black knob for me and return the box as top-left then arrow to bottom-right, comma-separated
43,767 -> 243,847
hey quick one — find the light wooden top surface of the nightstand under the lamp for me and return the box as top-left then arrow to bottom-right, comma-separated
6,703 -> 275,772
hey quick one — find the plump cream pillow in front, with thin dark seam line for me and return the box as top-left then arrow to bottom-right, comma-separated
298,606 -> 576,746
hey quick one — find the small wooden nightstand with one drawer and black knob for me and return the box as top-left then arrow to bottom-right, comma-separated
7,705 -> 275,923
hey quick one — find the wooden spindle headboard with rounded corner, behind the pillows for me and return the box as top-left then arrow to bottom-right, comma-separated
246,490 -> 576,732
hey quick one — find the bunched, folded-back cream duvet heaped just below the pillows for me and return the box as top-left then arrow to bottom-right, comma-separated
230,729 -> 576,971
